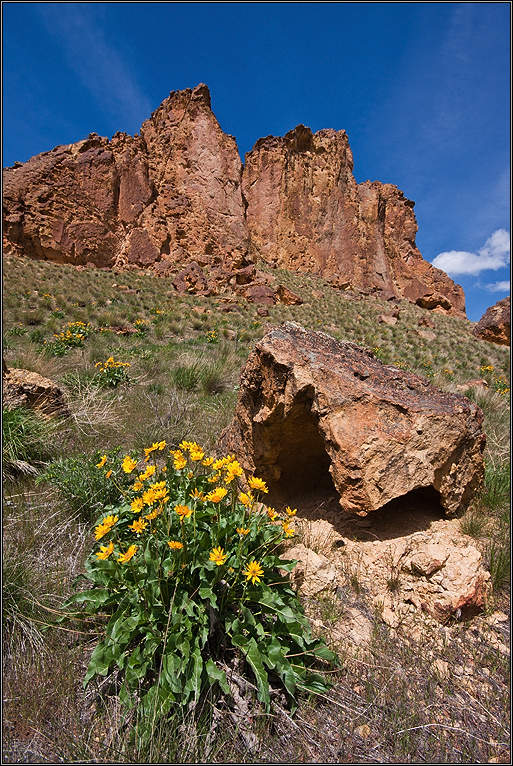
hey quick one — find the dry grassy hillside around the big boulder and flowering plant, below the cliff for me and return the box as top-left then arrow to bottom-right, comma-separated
3,258 -> 510,763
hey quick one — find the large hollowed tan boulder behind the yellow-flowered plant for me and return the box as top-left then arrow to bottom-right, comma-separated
220,323 -> 486,513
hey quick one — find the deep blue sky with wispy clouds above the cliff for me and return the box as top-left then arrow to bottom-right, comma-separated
2,2 -> 511,321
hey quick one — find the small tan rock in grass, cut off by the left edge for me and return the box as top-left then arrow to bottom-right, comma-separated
2,360 -> 69,417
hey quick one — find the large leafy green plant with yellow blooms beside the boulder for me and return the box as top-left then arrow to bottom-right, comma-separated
65,441 -> 338,732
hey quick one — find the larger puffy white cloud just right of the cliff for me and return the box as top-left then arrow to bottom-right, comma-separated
431,229 -> 510,277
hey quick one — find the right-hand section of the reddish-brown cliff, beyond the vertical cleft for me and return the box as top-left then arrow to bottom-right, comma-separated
242,130 -> 465,316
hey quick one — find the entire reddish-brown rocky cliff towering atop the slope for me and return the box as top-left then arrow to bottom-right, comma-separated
4,84 -> 465,317
